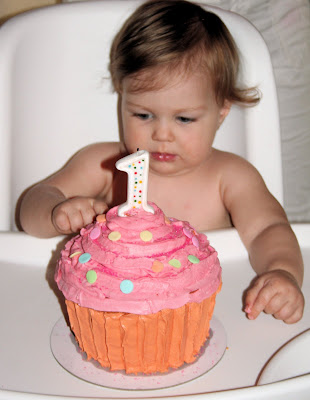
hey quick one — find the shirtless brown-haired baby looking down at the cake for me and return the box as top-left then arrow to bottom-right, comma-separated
20,0 -> 304,323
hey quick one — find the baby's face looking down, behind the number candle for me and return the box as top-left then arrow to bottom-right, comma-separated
121,69 -> 229,176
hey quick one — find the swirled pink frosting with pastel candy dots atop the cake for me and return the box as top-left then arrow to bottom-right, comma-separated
55,204 -> 221,314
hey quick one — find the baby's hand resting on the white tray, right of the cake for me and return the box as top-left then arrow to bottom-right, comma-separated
244,270 -> 305,324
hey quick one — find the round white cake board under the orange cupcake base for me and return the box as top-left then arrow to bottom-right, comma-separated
51,317 -> 226,390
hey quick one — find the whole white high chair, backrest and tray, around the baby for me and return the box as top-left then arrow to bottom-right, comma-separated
0,0 -> 310,400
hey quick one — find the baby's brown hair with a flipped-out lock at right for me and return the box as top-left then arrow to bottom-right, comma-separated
110,0 -> 260,105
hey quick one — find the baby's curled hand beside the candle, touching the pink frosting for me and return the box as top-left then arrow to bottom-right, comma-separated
52,197 -> 108,234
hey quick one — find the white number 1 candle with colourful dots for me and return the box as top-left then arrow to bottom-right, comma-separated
115,150 -> 154,217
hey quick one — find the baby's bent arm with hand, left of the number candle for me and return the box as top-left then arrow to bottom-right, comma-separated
20,143 -> 120,237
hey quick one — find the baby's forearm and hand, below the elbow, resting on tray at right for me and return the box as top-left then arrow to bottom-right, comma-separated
245,223 -> 304,323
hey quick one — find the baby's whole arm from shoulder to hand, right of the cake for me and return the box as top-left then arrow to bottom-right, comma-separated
223,153 -> 304,323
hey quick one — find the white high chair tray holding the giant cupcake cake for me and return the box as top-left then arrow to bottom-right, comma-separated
0,224 -> 310,400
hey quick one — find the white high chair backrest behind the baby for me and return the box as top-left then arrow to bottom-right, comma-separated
0,0 -> 282,230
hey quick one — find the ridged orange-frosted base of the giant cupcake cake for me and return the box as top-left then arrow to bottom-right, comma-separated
66,293 -> 217,374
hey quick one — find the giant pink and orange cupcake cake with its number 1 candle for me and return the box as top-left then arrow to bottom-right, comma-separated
55,152 -> 221,373
